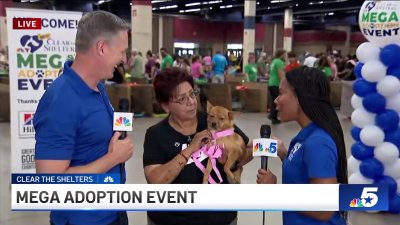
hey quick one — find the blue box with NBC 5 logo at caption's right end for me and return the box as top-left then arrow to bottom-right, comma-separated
339,184 -> 389,211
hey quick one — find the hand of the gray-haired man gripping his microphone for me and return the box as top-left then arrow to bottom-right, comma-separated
108,132 -> 133,163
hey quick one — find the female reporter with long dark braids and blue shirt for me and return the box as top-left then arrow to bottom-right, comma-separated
257,67 -> 347,225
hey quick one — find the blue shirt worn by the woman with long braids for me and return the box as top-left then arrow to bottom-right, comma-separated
282,123 -> 346,225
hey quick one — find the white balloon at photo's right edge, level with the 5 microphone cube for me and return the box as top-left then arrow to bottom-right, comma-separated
374,142 -> 400,164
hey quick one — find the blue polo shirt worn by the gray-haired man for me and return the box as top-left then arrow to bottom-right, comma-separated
34,61 -> 125,225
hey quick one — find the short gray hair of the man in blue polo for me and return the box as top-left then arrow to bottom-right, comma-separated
75,11 -> 130,52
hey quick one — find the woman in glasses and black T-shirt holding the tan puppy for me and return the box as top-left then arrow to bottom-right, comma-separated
143,68 -> 251,225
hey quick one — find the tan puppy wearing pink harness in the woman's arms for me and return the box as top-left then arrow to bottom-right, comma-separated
203,104 -> 246,184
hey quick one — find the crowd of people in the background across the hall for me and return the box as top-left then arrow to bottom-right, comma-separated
109,47 -> 357,87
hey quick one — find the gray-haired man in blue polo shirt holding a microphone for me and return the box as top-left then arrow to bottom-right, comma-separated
34,11 -> 133,225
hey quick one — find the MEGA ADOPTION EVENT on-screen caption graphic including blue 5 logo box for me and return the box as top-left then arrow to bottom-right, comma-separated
11,174 -> 389,211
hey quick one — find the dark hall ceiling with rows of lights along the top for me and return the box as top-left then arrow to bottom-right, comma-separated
13,0 -> 364,29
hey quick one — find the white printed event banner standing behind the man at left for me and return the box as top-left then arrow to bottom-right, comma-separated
7,8 -> 82,173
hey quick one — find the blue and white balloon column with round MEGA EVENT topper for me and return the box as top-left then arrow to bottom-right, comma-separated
348,1 -> 400,213
